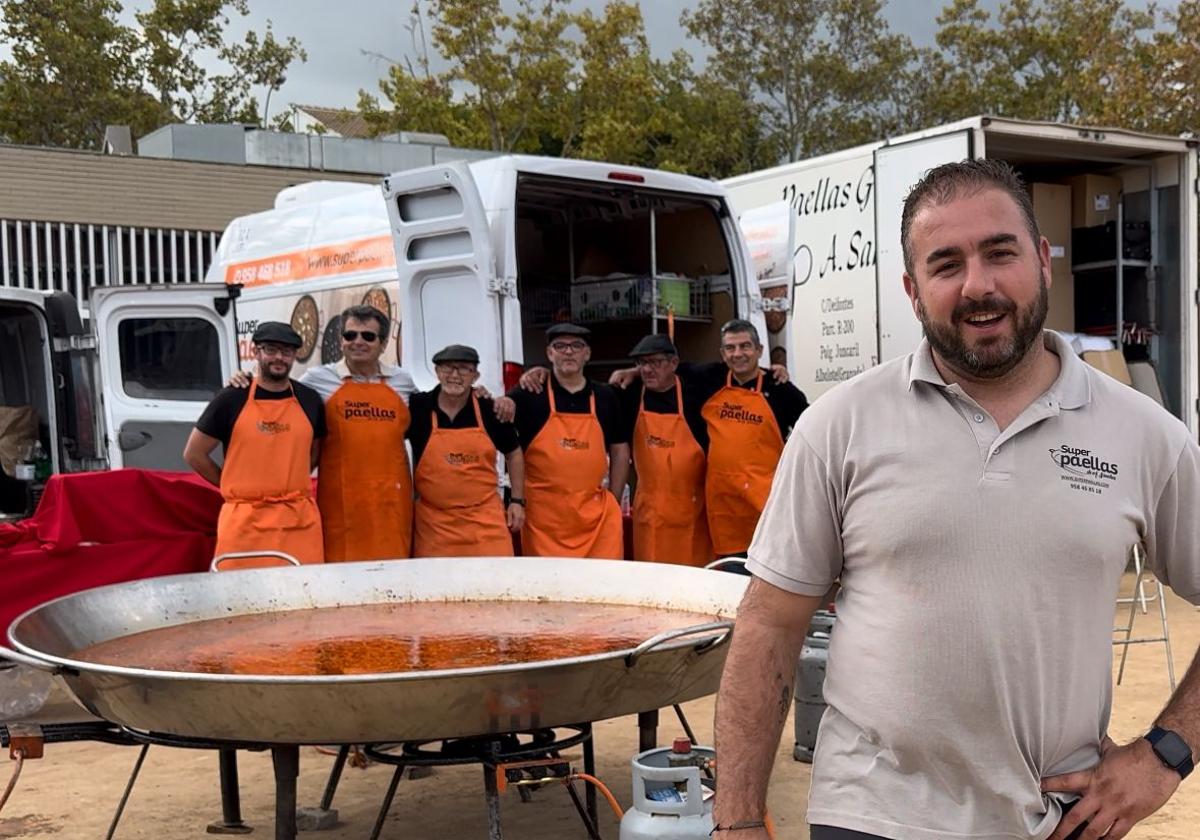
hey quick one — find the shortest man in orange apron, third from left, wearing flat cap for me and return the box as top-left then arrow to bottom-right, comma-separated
408,344 -> 526,557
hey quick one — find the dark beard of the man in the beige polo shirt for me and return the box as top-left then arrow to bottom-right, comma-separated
917,280 -> 1050,379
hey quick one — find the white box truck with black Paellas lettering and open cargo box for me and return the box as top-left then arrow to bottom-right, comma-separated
724,116 -> 1200,431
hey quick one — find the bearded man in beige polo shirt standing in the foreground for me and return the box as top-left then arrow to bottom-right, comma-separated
714,161 -> 1200,840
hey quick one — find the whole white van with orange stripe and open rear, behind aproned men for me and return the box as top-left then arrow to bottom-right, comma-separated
208,156 -> 762,390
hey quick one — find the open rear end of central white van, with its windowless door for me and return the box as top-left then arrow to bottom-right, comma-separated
384,156 -> 764,389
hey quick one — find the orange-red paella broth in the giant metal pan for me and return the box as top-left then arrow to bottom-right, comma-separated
74,601 -> 715,676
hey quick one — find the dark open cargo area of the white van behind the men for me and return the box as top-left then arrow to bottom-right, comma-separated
516,174 -> 734,378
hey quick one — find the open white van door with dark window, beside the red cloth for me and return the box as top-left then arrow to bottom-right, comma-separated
91,283 -> 238,470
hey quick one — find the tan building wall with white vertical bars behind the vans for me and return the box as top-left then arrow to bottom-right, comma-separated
0,144 -> 380,313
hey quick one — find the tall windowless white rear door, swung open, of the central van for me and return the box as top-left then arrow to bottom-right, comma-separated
383,162 -> 503,392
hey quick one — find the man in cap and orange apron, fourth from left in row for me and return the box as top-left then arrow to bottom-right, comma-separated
509,324 -> 629,559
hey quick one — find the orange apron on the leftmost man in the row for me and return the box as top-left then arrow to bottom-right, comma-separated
215,382 -> 324,570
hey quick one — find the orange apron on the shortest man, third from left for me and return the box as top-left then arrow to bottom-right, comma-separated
413,395 -> 512,557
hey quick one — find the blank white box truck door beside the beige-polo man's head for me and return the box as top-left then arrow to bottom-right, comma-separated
875,128 -> 973,361
